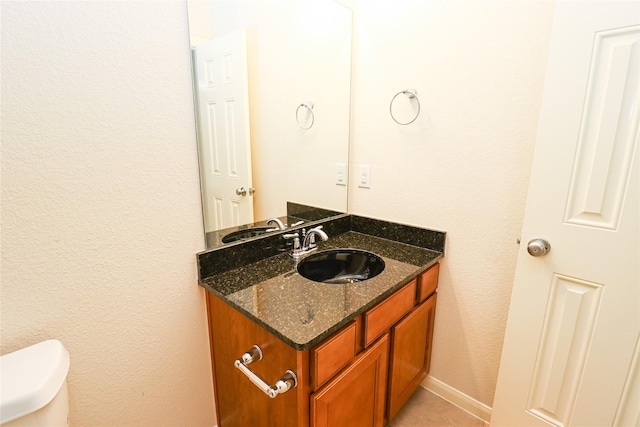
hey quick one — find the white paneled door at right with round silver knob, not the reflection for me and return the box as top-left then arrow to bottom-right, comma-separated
491,1 -> 640,426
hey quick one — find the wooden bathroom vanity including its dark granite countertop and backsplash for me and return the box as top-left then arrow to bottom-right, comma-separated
198,215 -> 445,427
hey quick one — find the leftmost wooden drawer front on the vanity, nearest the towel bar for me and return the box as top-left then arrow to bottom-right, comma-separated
311,322 -> 357,390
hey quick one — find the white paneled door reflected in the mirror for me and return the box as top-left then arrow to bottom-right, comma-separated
193,31 -> 253,232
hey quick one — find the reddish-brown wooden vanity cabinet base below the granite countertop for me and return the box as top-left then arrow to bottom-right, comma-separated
207,264 -> 438,427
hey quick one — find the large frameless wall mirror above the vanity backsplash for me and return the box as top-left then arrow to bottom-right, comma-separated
187,0 -> 352,249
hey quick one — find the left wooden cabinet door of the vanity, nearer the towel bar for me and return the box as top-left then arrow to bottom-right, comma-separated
311,334 -> 389,427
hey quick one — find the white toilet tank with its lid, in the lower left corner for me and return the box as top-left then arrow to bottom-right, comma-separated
0,340 -> 69,427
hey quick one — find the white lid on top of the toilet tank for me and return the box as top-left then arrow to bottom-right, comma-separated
0,340 -> 69,424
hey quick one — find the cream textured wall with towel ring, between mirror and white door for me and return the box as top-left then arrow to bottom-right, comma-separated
350,0 -> 553,406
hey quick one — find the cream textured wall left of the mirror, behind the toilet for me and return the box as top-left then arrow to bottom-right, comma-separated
1,1 -> 214,426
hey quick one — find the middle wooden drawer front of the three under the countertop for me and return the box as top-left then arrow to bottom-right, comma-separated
364,280 -> 416,347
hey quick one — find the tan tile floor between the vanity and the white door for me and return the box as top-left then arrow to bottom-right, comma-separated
388,387 -> 488,427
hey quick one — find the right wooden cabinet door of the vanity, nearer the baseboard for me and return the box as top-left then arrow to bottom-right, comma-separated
388,294 -> 436,421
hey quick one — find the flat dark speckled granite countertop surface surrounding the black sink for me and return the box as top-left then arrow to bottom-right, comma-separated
200,231 -> 443,350
